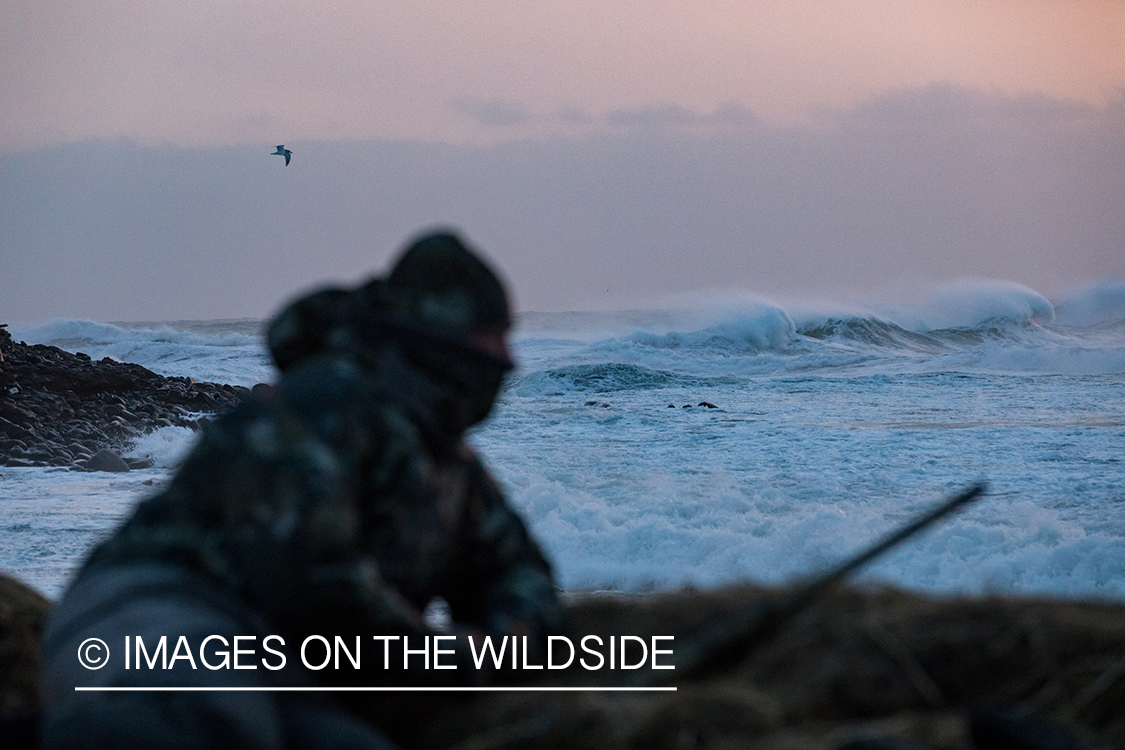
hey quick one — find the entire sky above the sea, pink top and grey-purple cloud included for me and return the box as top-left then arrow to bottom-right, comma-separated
0,0 -> 1125,322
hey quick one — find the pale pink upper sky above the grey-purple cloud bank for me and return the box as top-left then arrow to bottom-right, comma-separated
0,0 -> 1125,148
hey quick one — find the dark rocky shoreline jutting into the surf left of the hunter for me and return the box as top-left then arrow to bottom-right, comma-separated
0,325 -> 250,471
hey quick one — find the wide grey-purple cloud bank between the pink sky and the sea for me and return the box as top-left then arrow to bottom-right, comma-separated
0,89 -> 1125,323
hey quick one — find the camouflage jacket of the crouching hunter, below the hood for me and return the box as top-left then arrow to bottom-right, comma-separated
88,354 -> 561,652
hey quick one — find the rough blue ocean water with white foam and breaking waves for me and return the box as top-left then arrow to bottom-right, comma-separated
0,281 -> 1125,599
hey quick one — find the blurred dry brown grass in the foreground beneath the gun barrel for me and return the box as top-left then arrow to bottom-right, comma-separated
377,587 -> 1125,750
